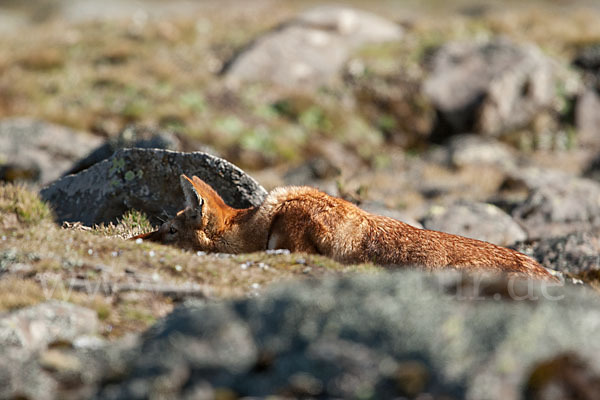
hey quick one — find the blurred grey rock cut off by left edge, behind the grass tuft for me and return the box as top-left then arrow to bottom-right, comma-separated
0,118 -> 101,185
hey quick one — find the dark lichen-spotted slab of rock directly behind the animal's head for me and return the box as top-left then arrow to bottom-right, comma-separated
41,149 -> 266,225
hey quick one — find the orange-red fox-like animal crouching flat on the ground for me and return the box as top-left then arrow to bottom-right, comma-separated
136,175 -> 552,279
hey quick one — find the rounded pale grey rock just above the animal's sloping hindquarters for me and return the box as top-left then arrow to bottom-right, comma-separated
423,201 -> 527,246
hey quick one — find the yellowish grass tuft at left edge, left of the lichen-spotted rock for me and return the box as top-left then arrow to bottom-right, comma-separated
0,184 -> 52,224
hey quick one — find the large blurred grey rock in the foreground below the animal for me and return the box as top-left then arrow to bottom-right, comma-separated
97,271 -> 600,399
